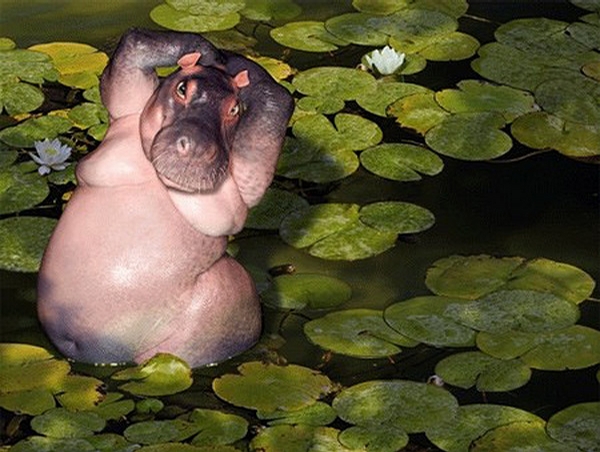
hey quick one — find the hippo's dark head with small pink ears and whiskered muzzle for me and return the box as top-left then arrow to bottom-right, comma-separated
140,54 -> 249,193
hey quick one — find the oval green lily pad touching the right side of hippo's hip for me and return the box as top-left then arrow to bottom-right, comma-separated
261,273 -> 352,309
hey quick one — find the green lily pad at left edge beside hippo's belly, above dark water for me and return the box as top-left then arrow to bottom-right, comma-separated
0,217 -> 57,272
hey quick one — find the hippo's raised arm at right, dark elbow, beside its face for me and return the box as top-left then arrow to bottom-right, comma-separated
225,53 -> 294,207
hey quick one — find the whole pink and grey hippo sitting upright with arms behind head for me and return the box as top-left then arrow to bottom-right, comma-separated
38,30 -> 292,366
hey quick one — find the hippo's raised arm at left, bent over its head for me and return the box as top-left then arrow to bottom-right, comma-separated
100,29 -> 223,119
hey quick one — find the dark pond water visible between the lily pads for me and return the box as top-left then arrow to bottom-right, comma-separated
0,0 -> 600,450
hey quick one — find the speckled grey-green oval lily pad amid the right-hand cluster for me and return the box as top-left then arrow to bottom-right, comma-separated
445,290 -> 579,333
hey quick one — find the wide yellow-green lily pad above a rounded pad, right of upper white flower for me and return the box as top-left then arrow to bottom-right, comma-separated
435,80 -> 536,122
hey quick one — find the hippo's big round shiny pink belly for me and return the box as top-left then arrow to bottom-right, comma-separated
38,184 -> 226,362
